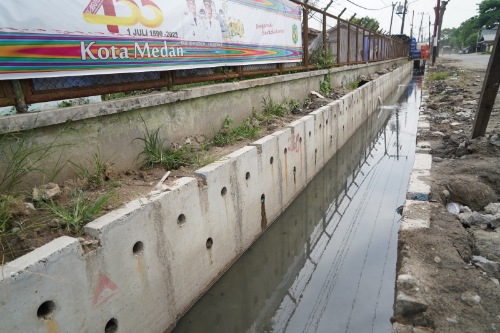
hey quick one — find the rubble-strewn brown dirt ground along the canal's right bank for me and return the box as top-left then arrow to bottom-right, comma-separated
393,58 -> 500,333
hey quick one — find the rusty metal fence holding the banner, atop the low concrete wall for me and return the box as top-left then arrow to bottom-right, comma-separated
0,0 -> 409,113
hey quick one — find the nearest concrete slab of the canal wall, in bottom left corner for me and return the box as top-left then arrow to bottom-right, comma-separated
0,236 -> 92,333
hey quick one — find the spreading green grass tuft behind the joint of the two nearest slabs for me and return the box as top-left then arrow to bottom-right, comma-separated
44,190 -> 113,235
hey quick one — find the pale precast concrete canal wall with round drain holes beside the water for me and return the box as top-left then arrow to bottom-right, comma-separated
0,63 -> 412,333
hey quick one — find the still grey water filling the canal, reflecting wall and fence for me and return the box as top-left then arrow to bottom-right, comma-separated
174,79 -> 420,333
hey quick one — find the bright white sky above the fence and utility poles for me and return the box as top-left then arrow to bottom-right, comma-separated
309,0 -> 481,36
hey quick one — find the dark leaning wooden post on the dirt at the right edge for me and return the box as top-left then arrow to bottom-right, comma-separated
472,29 -> 500,139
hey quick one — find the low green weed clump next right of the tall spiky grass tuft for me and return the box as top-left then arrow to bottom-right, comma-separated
211,116 -> 260,147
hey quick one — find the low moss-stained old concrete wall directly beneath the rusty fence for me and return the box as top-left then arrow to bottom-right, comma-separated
0,59 -> 405,185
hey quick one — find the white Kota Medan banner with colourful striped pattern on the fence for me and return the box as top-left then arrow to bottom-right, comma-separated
0,0 -> 302,80
